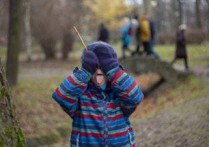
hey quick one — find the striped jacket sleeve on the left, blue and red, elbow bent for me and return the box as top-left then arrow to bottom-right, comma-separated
52,68 -> 91,118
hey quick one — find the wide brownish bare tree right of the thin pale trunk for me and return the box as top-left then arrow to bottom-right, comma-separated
31,0 -> 61,59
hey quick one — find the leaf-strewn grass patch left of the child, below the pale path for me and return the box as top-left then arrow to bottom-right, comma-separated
13,77 -> 71,138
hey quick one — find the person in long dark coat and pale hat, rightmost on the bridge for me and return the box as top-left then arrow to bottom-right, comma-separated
171,24 -> 189,69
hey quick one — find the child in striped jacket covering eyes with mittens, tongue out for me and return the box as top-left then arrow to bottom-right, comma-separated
52,41 -> 143,147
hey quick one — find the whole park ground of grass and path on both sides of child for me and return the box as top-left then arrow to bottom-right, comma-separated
1,44 -> 209,147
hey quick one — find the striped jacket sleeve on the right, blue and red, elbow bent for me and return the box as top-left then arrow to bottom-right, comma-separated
107,67 -> 144,116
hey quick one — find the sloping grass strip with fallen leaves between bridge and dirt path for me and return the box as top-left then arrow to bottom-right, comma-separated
131,75 -> 209,124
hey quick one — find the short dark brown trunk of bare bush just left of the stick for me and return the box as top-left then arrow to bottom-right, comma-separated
62,32 -> 74,60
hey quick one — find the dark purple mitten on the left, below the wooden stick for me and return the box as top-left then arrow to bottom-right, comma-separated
82,51 -> 99,75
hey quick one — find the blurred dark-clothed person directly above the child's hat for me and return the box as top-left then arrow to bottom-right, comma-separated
98,23 -> 109,42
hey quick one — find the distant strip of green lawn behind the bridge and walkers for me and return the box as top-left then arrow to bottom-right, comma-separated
0,42 -> 209,67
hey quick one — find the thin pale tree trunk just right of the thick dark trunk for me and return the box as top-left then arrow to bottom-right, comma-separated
24,0 -> 32,61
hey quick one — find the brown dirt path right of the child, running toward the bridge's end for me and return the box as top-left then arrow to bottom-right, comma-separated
134,68 -> 209,147
